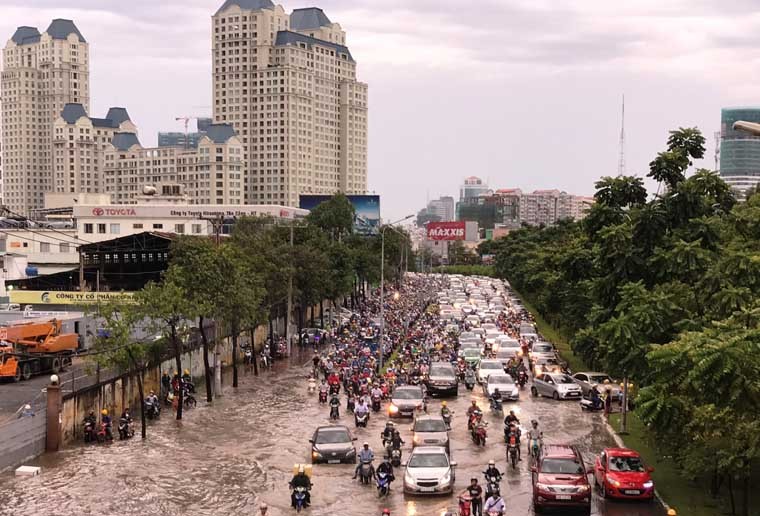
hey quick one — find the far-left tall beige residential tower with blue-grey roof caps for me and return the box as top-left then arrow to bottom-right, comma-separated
0,19 -> 90,215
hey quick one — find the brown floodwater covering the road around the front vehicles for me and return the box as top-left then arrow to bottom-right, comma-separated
0,348 -> 663,516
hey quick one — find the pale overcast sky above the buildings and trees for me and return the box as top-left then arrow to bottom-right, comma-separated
0,0 -> 760,217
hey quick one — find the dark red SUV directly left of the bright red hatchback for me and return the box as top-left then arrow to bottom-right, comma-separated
531,444 -> 591,514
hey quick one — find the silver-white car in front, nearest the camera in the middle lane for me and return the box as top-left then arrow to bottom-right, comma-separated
402,446 -> 457,494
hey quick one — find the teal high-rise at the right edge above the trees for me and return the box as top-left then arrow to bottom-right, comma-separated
720,107 -> 760,199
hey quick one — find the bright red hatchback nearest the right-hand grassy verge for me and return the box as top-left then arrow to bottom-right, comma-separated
594,448 -> 654,501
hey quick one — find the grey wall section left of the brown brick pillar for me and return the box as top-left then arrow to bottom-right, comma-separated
0,409 -> 47,472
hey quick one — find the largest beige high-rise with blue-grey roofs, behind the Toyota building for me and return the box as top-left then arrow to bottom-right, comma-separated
212,0 -> 367,206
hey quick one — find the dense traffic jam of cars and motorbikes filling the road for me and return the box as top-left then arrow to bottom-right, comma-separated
302,274 -> 663,516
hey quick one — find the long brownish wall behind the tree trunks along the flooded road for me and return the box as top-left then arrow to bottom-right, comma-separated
60,335 -> 235,444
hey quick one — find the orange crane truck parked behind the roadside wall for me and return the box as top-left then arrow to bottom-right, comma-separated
0,319 -> 79,382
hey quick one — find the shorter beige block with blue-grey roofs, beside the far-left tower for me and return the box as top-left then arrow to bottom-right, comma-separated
52,103 -> 137,194
